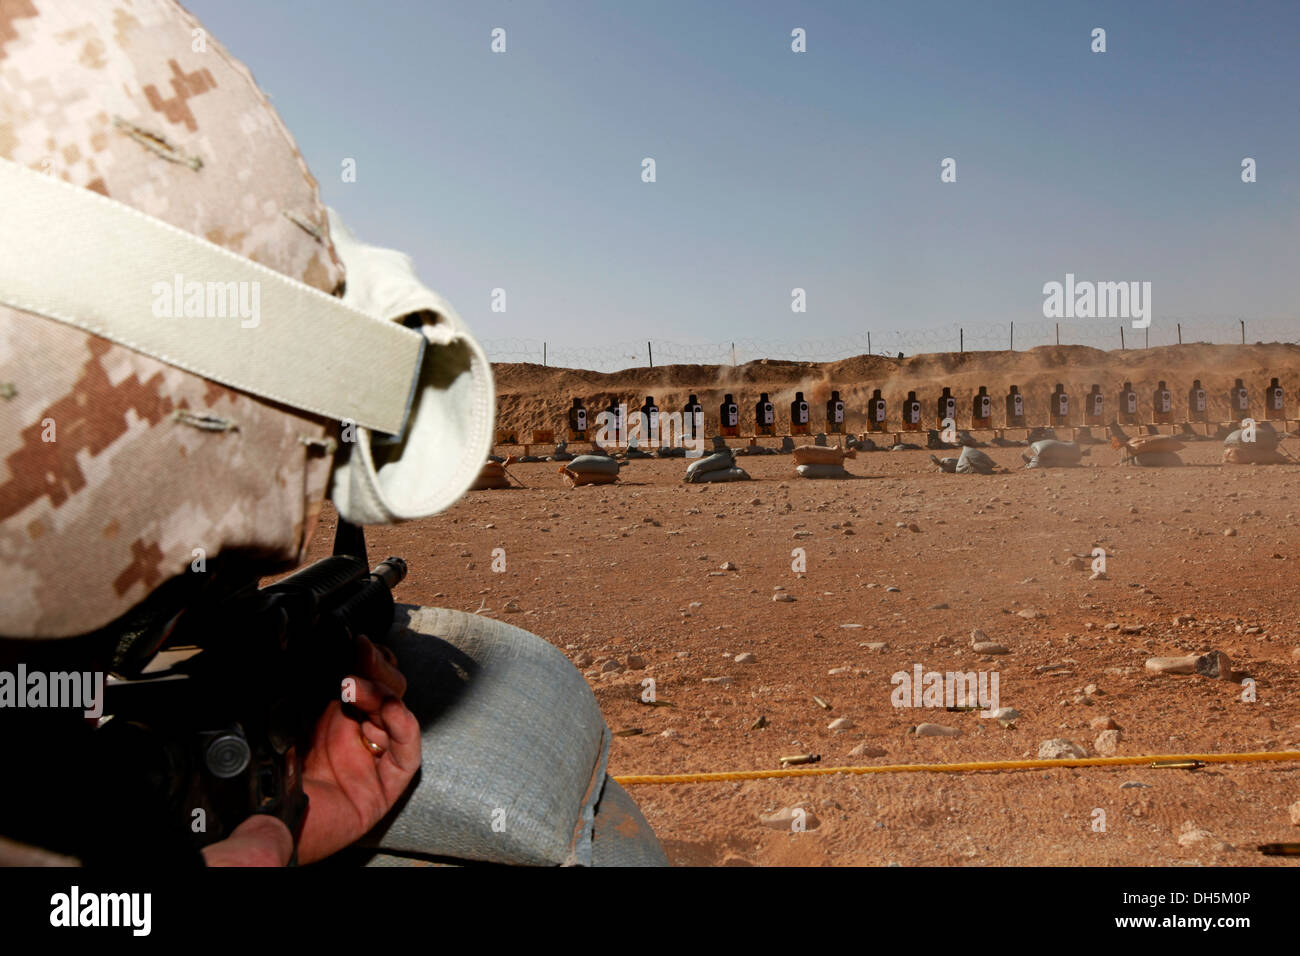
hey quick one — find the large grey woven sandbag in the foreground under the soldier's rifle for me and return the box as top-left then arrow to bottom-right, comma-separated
361,605 -> 667,866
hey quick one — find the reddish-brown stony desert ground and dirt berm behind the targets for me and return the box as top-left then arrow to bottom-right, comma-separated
301,346 -> 1300,865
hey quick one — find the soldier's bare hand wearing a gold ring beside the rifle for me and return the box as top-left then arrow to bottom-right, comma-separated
298,637 -> 420,864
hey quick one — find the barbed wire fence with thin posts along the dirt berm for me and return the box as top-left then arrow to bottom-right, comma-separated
481,316 -> 1300,372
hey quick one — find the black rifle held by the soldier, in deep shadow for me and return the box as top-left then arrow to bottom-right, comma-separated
96,522 -> 407,858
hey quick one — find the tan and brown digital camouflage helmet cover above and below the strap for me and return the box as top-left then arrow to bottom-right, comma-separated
0,0 -> 343,637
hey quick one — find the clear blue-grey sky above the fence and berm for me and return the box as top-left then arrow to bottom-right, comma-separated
186,0 -> 1300,346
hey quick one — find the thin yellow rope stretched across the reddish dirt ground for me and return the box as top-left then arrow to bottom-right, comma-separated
614,750 -> 1300,787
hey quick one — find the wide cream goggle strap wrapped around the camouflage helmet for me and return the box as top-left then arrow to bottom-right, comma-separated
0,159 -> 425,434
